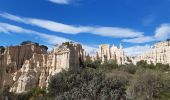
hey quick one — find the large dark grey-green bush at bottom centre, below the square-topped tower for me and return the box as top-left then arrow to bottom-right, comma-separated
48,68 -> 127,100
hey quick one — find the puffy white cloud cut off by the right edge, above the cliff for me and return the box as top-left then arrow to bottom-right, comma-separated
155,24 -> 170,40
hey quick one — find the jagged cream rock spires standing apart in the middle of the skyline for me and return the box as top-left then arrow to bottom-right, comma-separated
96,44 -> 127,65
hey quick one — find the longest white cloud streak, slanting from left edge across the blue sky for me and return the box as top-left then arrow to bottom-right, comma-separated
0,13 -> 144,38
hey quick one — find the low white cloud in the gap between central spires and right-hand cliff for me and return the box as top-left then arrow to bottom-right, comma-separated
124,45 -> 151,56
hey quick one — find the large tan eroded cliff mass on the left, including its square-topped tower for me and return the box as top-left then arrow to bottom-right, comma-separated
0,42 -> 84,93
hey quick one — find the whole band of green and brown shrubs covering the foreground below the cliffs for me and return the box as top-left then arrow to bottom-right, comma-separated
4,60 -> 170,100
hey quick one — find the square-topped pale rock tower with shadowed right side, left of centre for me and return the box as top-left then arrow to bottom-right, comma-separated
48,44 -> 84,75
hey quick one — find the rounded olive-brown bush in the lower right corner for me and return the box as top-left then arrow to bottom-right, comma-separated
127,69 -> 168,100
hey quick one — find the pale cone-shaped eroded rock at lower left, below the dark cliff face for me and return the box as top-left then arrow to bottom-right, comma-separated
10,60 -> 38,93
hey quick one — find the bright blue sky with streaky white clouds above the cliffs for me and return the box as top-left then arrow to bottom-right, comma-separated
0,0 -> 170,56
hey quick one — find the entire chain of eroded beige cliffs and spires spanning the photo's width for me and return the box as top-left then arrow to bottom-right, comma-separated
0,41 -> 170,95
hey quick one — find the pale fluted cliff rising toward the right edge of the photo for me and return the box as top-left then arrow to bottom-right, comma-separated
133,41 -> 170,65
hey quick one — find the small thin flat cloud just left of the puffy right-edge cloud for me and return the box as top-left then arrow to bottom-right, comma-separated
122,36 -> 155,43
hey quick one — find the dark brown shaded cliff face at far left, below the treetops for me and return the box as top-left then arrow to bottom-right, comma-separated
5,44 -> 46,72
